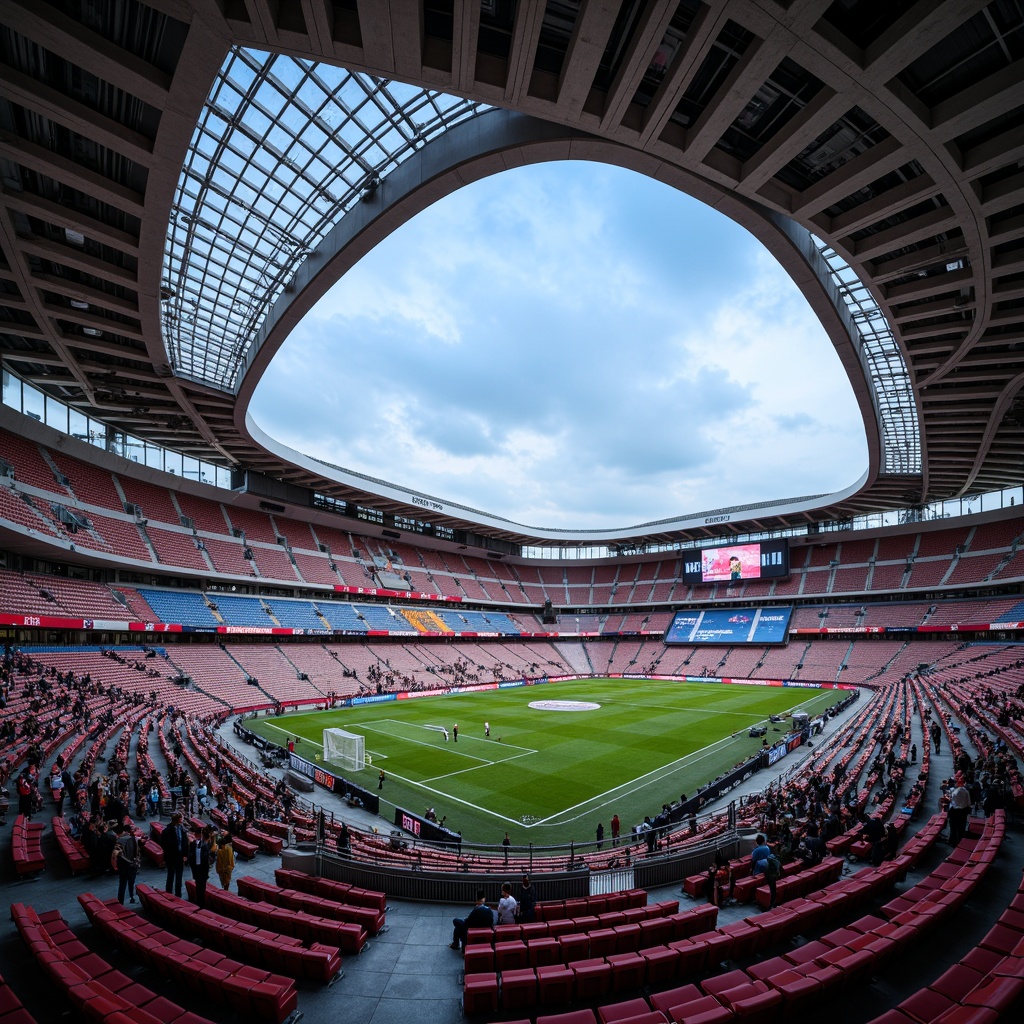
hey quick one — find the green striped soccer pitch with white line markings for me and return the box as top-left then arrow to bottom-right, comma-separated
246,679 -> 846,847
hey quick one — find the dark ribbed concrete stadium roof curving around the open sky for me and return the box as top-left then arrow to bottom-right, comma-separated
0,0 -> 1024,545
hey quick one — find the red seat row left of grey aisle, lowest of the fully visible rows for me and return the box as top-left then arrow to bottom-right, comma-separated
78,893 -> 298,1024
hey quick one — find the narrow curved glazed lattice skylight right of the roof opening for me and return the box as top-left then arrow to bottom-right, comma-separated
812,237 -> 922,474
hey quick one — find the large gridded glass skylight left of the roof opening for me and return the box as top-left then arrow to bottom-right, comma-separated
163,47 -> 487,389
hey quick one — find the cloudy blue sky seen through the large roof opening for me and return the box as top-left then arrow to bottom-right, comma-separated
252,162 -> 867,528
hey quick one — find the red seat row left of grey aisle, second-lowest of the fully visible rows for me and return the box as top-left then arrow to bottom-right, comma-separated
137,885 -> 341,984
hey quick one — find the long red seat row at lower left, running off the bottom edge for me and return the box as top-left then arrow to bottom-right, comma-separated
10,903 -> 210,1024
